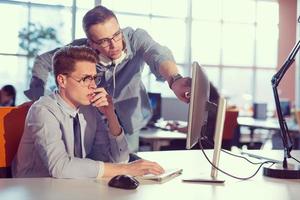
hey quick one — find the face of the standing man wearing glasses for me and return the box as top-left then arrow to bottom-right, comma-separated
89,18 -> 123,60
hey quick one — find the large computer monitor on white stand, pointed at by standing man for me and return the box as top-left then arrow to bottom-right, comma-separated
183,62 -> 226,183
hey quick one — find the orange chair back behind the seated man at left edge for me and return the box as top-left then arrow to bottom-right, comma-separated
0,102 -> 33,178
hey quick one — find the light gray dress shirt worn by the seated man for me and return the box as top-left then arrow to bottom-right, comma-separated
12,93 -> 129,178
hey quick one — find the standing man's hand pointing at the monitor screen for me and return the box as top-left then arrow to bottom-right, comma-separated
172,77 -> 192,103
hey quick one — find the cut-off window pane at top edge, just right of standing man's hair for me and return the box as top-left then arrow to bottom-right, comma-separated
101,0 -> 151,15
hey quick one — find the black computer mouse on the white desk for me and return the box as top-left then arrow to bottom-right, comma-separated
108,175 -> 140,190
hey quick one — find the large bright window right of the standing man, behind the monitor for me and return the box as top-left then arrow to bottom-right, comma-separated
102,0 -> 279,112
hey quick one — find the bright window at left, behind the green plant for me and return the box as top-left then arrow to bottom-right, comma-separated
0,0 -> 95,104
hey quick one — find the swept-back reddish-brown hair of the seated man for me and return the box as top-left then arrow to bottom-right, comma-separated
52,46 -> 99,85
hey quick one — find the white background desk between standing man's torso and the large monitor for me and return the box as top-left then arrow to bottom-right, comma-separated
139,128 -> 186,151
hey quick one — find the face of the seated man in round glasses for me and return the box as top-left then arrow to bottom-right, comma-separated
60,61 -> 97,108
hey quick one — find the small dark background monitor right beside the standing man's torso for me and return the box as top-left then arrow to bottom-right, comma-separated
148,92 -> 161,126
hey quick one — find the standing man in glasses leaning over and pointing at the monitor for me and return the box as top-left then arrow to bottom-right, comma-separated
25,6 -> 190,152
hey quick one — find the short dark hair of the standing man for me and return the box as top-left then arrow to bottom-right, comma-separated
82,6 -> 117,37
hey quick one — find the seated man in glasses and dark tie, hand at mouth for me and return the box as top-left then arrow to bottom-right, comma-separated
12,46 -> 164,178
